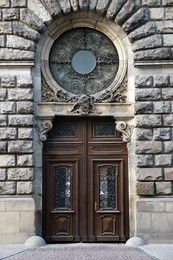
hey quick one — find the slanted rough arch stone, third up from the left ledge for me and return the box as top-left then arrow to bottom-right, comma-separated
13,22 -> 40,42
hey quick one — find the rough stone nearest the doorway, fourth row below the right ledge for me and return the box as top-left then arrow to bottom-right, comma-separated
136,115 -> 162,127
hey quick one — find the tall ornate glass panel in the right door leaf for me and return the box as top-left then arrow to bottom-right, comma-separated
99,165 -> 117,209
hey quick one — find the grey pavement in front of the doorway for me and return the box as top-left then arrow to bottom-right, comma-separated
0,243 -> 173,260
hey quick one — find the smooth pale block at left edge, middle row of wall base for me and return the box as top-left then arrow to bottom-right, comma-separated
0,212 -> 20,233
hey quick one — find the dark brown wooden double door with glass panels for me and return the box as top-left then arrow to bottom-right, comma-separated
43,117 -> 128,242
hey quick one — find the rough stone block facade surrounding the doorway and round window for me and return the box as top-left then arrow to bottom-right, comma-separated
0,0 -> 173,243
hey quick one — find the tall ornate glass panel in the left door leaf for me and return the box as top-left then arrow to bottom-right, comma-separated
55,165 -> 72,209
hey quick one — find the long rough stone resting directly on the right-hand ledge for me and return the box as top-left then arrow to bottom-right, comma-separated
134,48 -> 172,60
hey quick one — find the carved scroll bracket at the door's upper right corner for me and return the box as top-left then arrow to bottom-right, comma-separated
116,121 -> 134,143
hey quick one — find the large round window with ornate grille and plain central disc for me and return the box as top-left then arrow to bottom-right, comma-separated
49,28 -> 119,95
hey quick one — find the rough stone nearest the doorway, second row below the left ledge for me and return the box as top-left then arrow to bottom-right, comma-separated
8,88 -> 34,101
